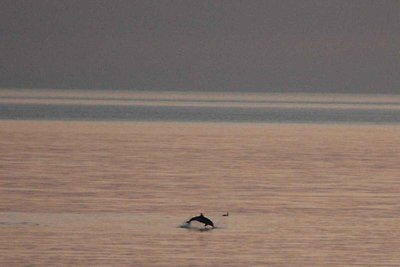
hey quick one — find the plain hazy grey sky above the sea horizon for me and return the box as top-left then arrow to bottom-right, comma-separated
0,0 -> 400,93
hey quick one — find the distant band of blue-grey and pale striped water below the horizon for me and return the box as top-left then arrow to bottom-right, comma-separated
0,91 -> 400,124
